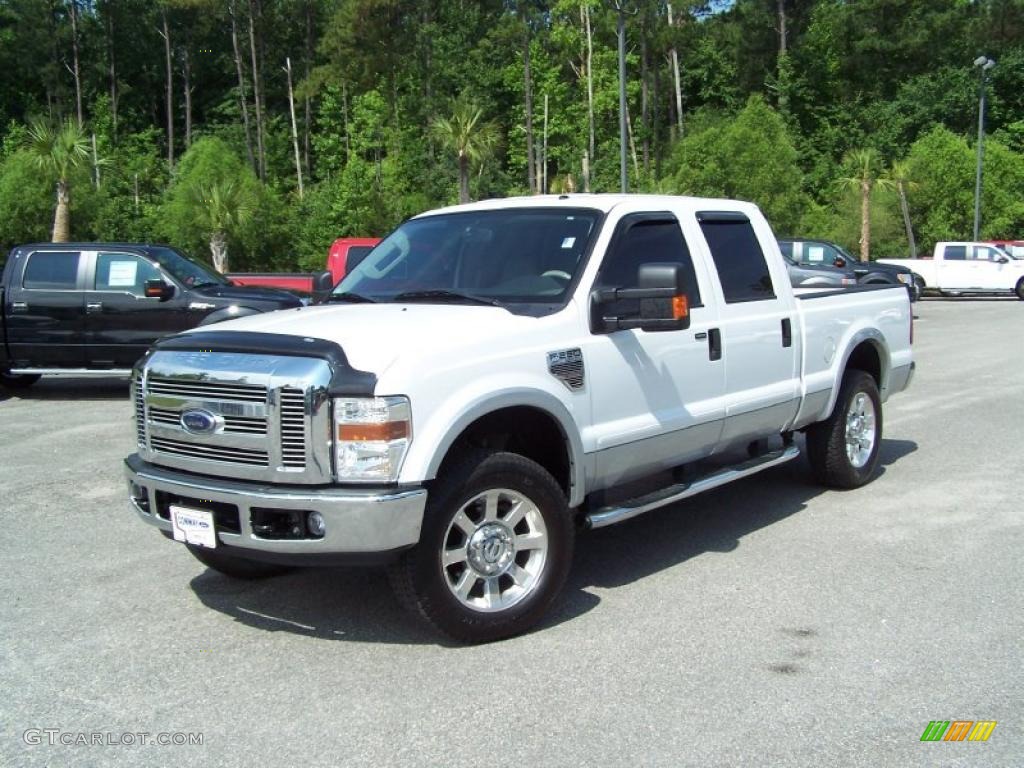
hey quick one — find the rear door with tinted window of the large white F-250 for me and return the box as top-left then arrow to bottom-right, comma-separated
697,211 -> 800,447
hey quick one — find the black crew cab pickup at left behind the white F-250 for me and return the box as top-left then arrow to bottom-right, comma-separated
0,243 -> 303,388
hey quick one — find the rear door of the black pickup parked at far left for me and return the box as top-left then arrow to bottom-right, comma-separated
4,248 -> 85,369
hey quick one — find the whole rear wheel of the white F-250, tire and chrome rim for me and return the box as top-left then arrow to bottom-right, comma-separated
807,369 -> 882,488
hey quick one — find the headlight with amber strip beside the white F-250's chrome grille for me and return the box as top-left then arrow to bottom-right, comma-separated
334,397 -> 413,482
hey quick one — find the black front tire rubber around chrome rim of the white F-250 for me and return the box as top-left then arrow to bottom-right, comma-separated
388,451 -> 575,643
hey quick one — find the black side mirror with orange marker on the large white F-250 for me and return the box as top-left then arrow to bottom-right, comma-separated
590,263 -> 690,333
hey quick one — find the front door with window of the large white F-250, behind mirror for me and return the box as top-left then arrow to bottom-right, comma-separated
583,211 -> 725,487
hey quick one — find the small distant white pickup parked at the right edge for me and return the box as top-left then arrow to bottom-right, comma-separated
879,243 -> 1024,299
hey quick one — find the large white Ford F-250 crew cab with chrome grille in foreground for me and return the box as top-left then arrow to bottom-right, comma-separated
125,195 -> 913,642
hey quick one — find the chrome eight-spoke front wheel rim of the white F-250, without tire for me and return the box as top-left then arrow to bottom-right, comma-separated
440,488 -> 548,613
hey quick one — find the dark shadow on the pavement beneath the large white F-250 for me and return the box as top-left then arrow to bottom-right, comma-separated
190,439 -> 918,647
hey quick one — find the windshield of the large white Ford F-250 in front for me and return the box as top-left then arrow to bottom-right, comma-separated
334,208 -> 601,305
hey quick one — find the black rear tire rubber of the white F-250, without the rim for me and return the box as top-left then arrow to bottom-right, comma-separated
807,369 -> 882,488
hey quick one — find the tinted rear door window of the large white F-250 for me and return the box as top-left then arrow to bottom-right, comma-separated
697,217 -> 775,304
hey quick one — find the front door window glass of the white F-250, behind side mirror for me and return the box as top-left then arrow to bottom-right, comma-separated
595,214 -> 702,312
